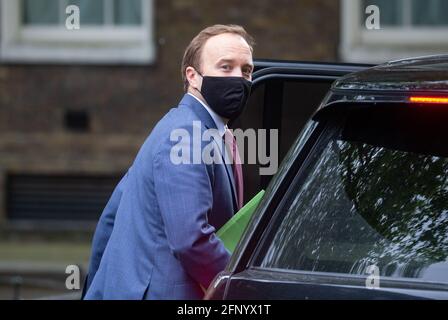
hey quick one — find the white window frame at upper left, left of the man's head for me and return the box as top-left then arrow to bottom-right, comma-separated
0,0 -> 155,64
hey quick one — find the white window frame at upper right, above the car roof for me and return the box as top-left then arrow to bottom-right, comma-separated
339,0 -> 448,63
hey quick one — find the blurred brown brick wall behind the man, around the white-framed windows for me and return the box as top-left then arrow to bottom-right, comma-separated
0,0 -> 339,220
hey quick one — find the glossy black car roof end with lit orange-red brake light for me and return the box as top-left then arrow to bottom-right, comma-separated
315,54 -> 448,116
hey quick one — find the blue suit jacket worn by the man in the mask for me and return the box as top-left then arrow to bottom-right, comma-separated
84,94 -> 236,299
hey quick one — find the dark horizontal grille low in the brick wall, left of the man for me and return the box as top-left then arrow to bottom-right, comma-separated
6,174 -> 120,221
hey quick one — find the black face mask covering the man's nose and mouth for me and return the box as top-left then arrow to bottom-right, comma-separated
198,72 -> 252,120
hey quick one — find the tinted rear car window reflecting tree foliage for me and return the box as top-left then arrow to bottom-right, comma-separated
255,107 -> 448,283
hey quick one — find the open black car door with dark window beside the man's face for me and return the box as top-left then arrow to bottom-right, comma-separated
230,60 -> 371,200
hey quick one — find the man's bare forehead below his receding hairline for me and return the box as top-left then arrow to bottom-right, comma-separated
202,33 -> 252,62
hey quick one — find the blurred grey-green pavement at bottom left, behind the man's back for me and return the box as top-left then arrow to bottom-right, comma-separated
0,240 -> 90,300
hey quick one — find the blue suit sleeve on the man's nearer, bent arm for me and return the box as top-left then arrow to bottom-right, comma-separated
153,129 -> 230,288
